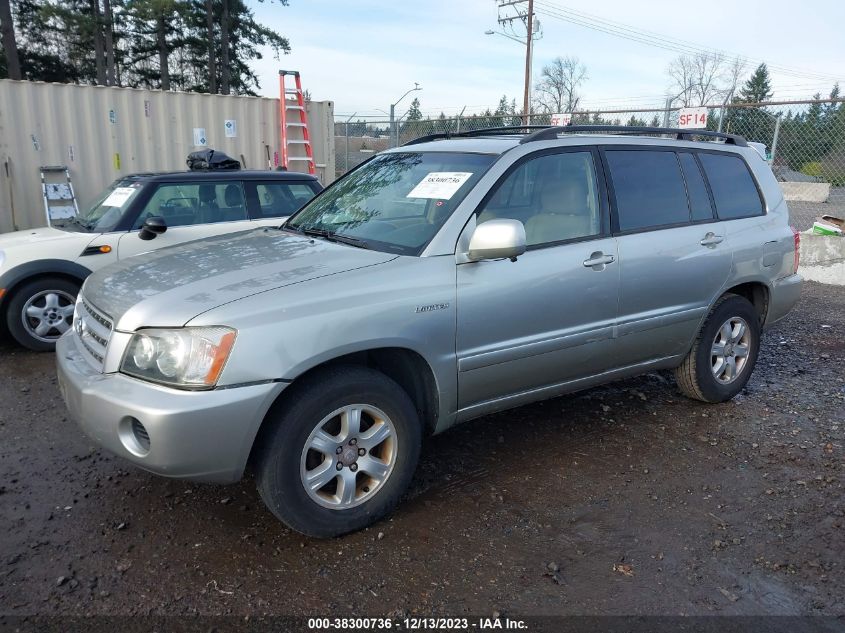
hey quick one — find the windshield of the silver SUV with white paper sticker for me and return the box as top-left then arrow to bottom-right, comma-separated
284,152 -> 496,255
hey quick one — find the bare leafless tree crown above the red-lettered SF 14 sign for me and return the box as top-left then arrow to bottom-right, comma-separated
666,51 -> 745,107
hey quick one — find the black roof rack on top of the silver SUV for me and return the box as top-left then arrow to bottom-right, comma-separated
403,125 -> 748,147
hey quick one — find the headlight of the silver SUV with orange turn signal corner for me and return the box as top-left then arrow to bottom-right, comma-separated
120,327 -> 236,389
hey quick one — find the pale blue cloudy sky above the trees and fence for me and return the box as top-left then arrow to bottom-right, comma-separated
250,0 -> 845,119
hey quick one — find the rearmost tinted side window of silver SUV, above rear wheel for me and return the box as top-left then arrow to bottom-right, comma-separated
698,153 -> 763,220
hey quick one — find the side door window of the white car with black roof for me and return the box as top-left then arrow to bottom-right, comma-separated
134,181 -> 246,229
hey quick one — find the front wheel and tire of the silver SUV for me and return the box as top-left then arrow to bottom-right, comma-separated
255,365 -> 422,538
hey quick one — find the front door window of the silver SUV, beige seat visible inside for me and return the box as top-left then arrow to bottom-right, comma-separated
478,152 -> 601,246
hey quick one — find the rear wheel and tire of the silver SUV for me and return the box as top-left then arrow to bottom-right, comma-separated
675,294 -> 760,402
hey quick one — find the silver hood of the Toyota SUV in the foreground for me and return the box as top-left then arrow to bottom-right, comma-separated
83,228 -> 396,332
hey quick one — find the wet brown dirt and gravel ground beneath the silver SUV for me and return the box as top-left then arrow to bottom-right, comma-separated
0,283 -> 845,616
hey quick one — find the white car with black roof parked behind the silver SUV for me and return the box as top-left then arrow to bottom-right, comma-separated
0,170 -> 322,351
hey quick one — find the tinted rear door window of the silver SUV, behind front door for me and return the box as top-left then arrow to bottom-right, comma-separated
606,150 -> 690,231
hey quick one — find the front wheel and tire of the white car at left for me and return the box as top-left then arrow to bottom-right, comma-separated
6,277 -> 79,352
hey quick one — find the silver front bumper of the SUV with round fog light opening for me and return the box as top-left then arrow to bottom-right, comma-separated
56,331 -> 285,483
